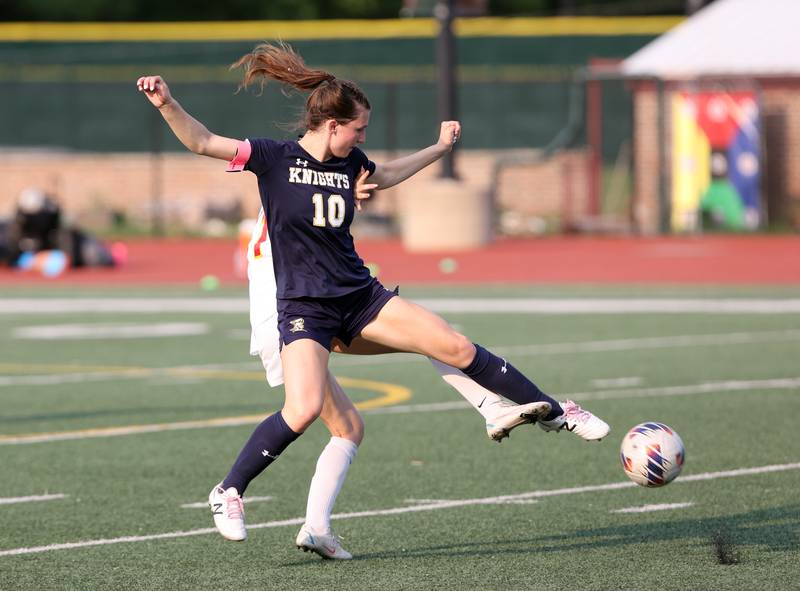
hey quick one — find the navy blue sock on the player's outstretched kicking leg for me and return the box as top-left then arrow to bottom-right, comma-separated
461,344 -> 564,421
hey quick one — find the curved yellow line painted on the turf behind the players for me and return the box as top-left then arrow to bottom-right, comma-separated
0,363 -> 412,445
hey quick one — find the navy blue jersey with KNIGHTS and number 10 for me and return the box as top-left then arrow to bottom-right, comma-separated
246,138 -> 375,299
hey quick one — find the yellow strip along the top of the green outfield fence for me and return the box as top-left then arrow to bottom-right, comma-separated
0,17 -> 683,42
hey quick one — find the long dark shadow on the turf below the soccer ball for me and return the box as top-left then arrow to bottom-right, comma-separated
282,504 -> 800,566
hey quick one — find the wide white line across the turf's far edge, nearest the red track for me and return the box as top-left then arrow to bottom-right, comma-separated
0,297 -> 800,315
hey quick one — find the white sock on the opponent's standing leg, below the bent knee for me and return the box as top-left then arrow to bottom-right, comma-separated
306,437 -> 358,534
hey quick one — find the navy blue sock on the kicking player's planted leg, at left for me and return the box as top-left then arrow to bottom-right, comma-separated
222,412 -> 300,495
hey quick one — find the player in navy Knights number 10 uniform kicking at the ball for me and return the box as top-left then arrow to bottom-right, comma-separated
137,44 -> 609,558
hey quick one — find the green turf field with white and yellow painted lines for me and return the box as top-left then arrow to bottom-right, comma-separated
0,287 -> 800,590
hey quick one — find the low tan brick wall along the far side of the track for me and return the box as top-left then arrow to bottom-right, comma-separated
0,151 -> 586,236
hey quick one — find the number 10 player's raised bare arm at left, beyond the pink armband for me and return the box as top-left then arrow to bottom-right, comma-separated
136,76 -> 239,160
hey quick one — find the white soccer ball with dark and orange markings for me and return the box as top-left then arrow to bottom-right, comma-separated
619,422 -> 686,487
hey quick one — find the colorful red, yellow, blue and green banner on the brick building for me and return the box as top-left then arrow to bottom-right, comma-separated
672,92 -> 761,232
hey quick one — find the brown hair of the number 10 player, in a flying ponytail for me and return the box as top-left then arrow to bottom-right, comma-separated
231,43 -> 371,129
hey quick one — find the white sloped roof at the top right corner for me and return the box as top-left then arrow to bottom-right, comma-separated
622,0 -> 800,79
